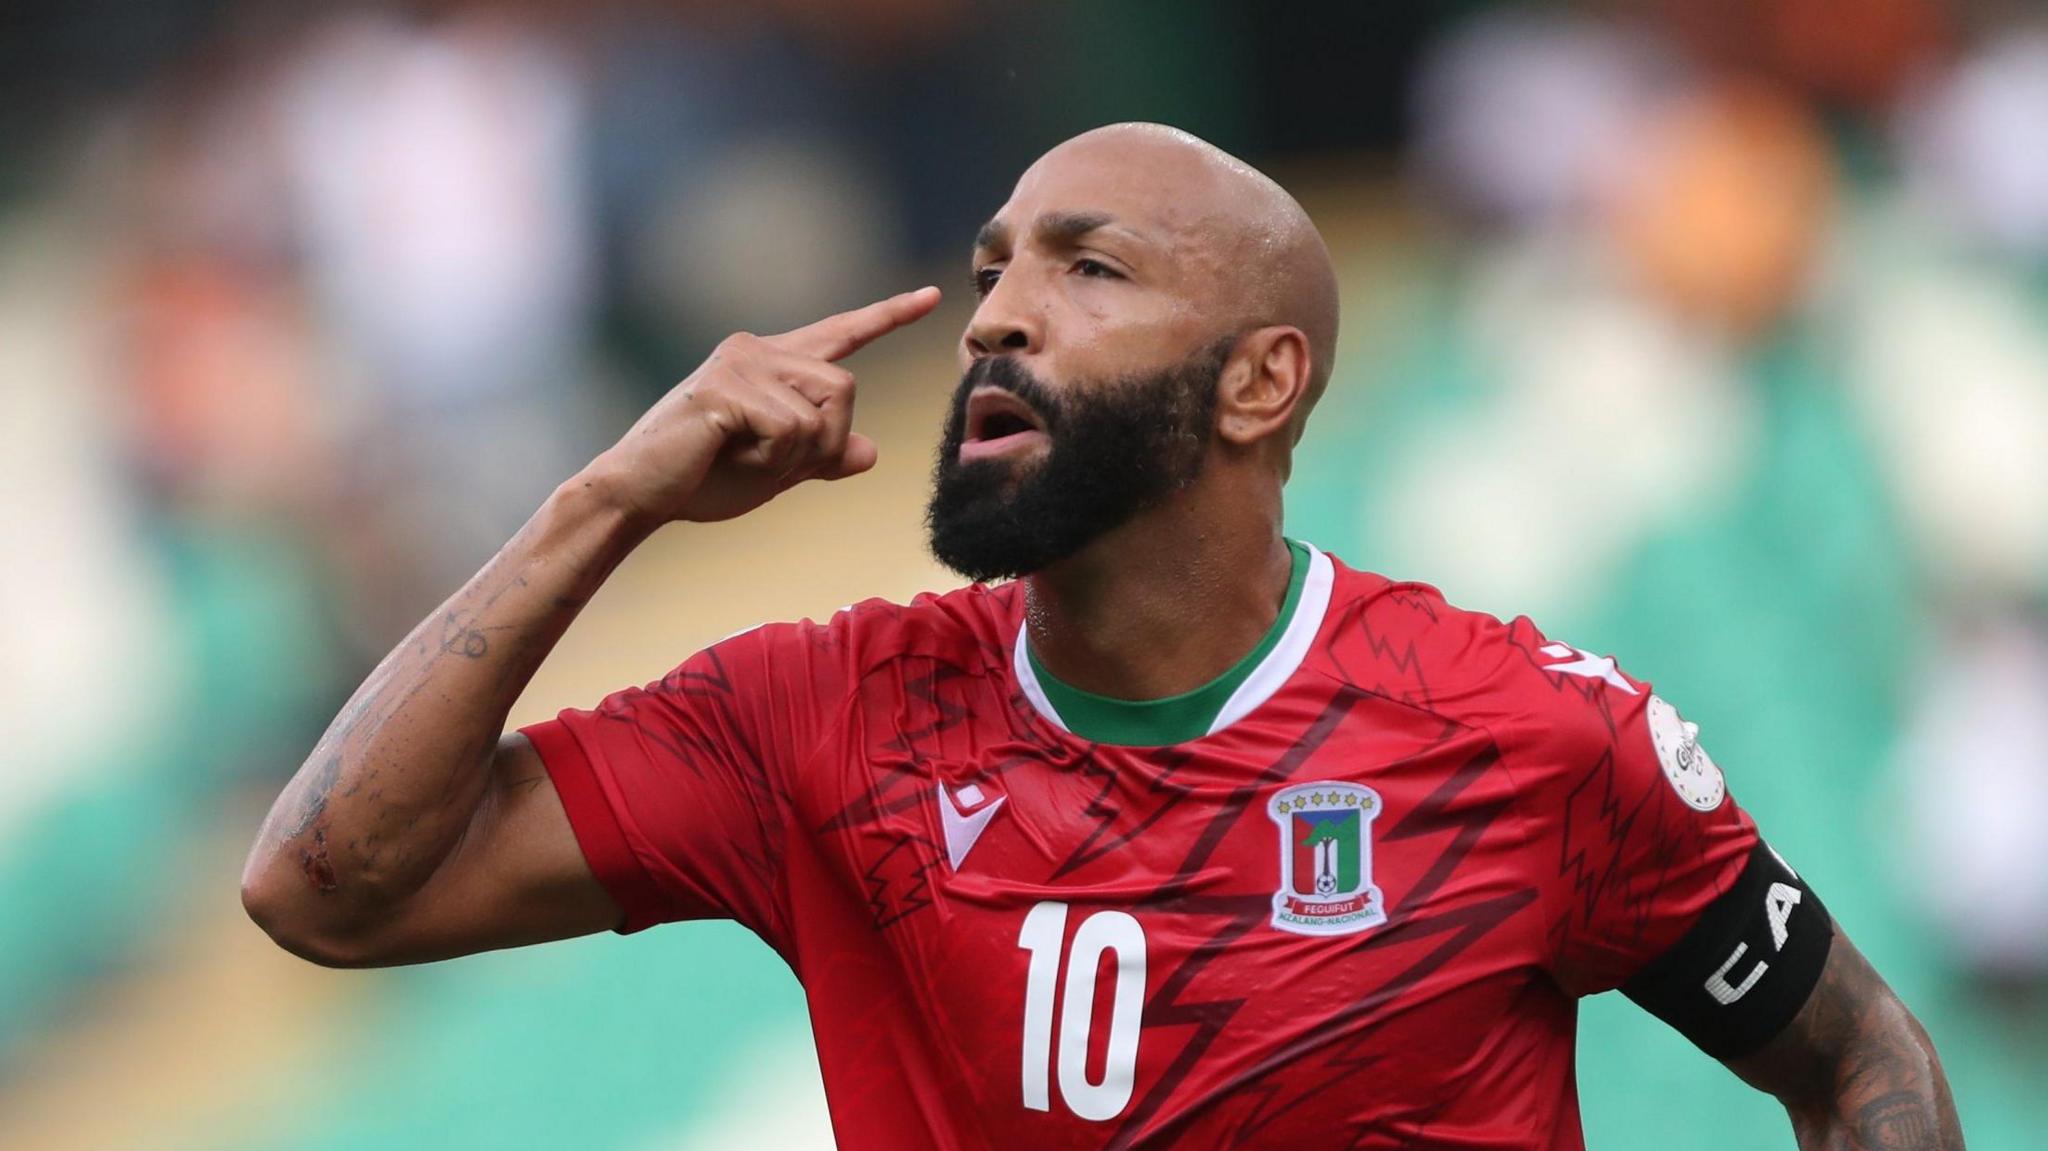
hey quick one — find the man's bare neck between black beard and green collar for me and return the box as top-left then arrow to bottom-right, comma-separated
1024,491 -> 1292,700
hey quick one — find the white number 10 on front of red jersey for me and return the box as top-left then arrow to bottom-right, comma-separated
1018,901 -> 1145,1122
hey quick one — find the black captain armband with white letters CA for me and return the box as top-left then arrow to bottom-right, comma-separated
1622,842 -> 1835,1059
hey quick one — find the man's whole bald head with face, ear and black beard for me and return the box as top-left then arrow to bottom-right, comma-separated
928,125 -> 1337,580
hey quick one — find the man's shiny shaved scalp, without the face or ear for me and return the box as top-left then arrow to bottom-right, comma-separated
1018,123 -> 1337,438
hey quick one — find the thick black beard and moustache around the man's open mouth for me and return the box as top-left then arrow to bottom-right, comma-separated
924,336 -> 1237,582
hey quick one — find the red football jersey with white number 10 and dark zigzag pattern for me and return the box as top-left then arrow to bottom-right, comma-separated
524,551 -> 1757,1151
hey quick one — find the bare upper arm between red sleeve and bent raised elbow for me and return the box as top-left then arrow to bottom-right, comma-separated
344,731 -> 623,967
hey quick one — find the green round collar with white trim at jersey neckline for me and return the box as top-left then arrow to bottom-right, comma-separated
1018,539 -> 1329,748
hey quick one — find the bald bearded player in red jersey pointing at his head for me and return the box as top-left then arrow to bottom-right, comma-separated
242,125 -> 1960,1151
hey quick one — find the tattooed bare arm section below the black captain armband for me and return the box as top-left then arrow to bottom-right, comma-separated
1729,934 -> 1962,1151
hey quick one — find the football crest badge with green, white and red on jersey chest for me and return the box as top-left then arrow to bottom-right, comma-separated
1266,782 -> 1386,936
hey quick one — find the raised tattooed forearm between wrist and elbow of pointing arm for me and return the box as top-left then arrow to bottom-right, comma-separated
244,471 -> 647,924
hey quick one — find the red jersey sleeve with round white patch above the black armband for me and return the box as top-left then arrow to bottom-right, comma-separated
1482,619 -> 1759,995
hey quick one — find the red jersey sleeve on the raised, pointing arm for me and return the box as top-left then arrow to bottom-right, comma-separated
520,621 -> 844,956
